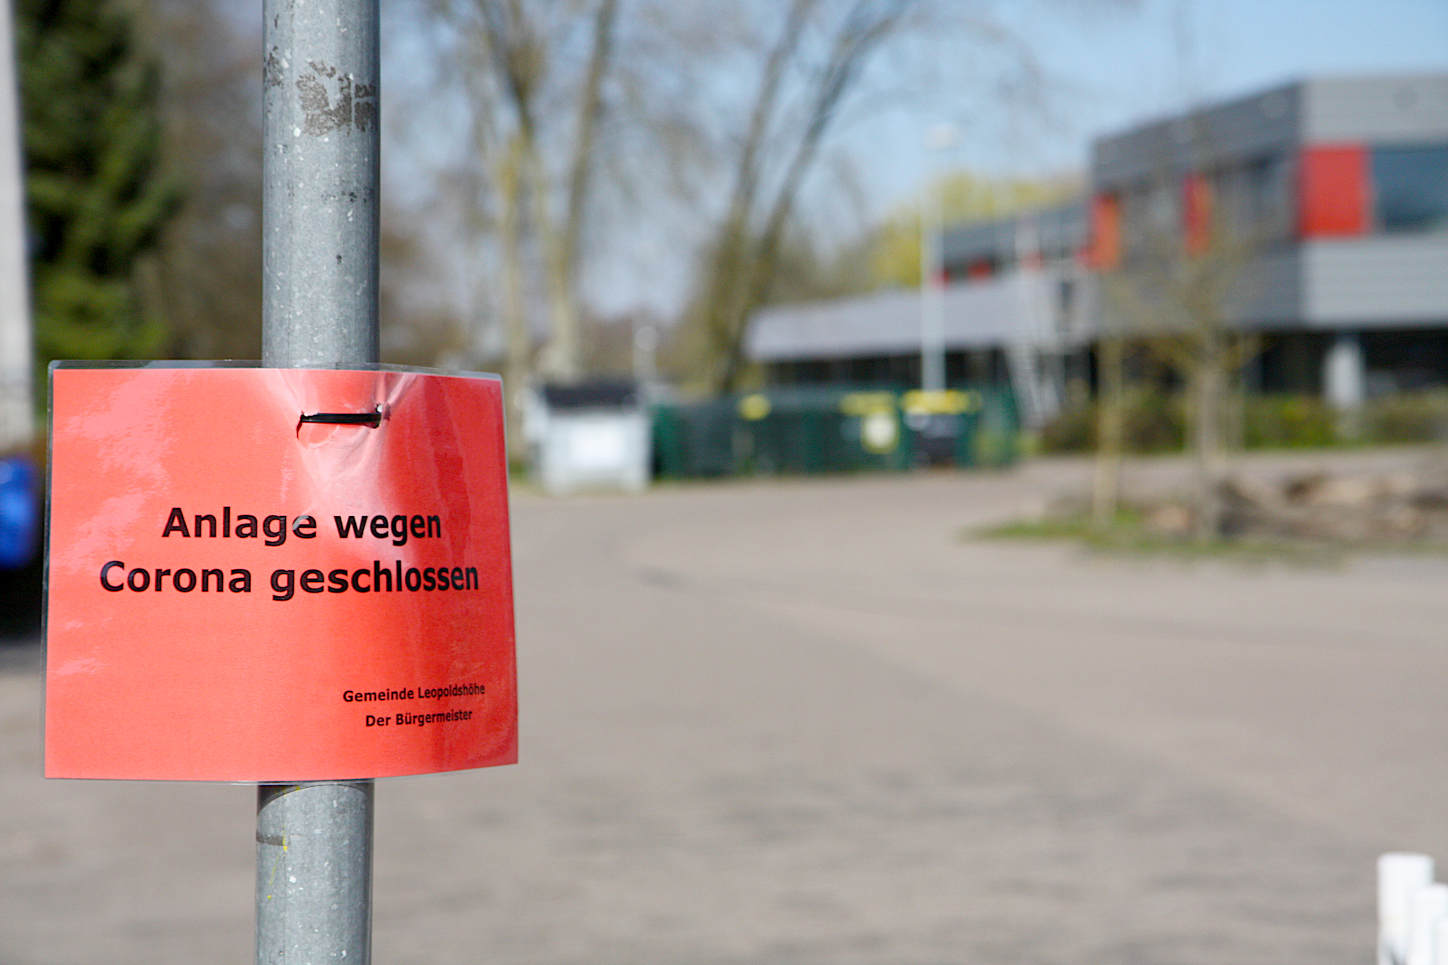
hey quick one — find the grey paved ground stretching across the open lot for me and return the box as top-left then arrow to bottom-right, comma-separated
0,454 -> 1448,965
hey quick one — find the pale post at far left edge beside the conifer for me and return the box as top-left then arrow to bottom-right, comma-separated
0,0 -> 35,454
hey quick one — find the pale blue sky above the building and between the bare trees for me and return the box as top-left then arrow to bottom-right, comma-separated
376,0 -> 1448,312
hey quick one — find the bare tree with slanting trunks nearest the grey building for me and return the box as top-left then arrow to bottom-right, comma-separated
686,0 -> 1094,391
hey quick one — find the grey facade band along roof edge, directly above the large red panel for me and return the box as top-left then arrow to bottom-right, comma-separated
1302,74 -> 1448,145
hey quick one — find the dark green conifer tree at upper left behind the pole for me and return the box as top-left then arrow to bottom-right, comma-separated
16,0 -> 180,368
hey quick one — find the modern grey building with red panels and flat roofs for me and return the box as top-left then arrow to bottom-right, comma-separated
749,74 -> 1448,422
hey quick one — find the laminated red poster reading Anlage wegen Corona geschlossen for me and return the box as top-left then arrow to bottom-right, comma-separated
45,367 -> 517,782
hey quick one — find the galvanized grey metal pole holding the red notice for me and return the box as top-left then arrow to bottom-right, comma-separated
256,0 -> 379,965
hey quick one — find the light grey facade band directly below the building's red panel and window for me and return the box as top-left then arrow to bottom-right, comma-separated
1302,235 -> 1448,329
